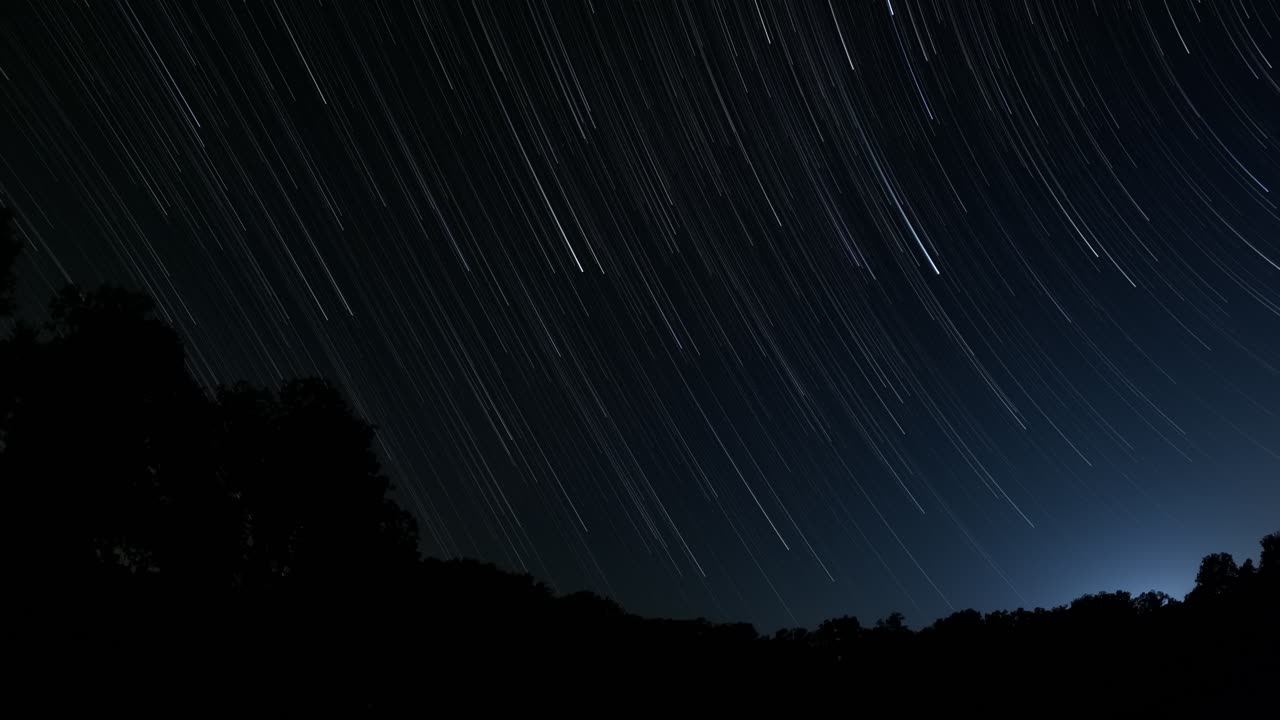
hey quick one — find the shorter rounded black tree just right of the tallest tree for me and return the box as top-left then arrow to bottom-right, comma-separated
214,379 -> 417,591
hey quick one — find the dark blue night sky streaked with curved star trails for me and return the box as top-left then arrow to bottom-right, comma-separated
0,0 -> 1280,630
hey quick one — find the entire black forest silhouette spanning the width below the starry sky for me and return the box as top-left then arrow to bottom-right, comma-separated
0,202 -> 1280,716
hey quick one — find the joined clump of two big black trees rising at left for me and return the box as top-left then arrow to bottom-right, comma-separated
0,278 -> 419,630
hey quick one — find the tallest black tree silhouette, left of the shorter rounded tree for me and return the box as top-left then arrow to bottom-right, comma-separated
0,283 -> 209,594
